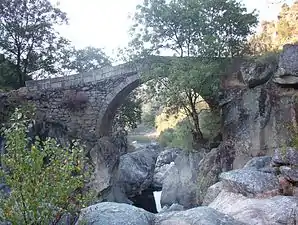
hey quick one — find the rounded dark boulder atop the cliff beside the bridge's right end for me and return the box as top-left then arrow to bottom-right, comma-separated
240,62 -> 277,88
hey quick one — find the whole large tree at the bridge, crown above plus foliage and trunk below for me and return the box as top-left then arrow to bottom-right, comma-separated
130,0 -> 257,146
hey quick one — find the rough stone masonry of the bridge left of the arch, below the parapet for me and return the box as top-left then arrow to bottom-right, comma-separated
26,73 -> 139,140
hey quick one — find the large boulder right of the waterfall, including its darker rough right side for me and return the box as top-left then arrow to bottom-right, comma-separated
161,143 -> 233,209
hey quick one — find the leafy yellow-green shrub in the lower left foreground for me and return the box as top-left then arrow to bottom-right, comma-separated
0,106 -> 92,225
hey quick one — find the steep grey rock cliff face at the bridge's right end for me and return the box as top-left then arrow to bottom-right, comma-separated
221,45 -> 298,169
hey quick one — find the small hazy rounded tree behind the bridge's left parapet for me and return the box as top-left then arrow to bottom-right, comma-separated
63,47 -> 111,73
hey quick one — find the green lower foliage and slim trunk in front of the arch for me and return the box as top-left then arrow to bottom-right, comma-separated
144,58 -> 222,143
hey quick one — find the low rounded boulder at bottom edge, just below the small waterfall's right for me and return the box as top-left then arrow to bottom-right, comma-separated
155,207 -> 244,225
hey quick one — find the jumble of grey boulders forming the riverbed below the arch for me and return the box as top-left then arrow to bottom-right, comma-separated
80,142 -> 298,225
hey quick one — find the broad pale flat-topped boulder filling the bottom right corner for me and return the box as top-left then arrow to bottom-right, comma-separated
209,191 -> 298,225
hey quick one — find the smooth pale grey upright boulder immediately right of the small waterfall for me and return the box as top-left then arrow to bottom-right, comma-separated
160,152 -> 202,208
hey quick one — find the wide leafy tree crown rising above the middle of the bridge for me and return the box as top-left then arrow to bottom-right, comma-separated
131,0 -> 257,57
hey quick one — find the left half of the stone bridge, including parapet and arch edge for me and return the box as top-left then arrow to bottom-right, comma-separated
26,56 -> 178,139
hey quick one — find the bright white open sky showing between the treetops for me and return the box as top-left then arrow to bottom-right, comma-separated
52,0 -> 293,56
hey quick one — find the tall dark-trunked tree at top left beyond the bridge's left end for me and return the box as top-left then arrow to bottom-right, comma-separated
0,0 -> 69,87
